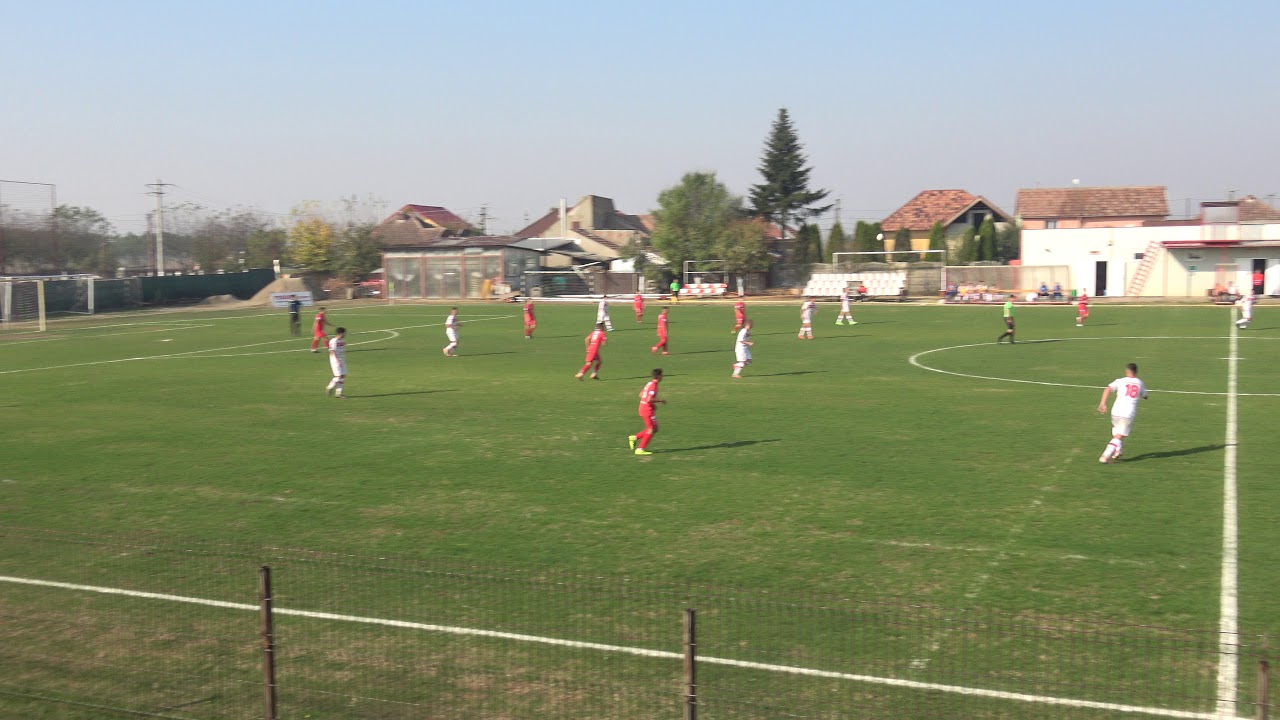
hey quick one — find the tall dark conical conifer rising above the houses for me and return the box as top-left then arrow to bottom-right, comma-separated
750,108 -> 831,240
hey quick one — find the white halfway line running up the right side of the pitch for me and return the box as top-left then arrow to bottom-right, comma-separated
1217,309 -> 1240,717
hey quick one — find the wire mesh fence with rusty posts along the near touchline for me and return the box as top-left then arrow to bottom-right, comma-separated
0,528 -> 1270,720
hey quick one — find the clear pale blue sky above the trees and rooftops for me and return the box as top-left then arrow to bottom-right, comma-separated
0,0 -> 1280,231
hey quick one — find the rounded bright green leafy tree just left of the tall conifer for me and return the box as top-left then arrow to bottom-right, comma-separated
652,173 -> 744,272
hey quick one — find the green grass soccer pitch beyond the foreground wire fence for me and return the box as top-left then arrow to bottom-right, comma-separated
0,297 -> 1280,716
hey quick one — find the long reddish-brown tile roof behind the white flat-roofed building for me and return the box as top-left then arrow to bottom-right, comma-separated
1015,184 -> 1169,231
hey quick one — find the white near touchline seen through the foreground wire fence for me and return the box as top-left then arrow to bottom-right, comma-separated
0,575 -> 1221,720
